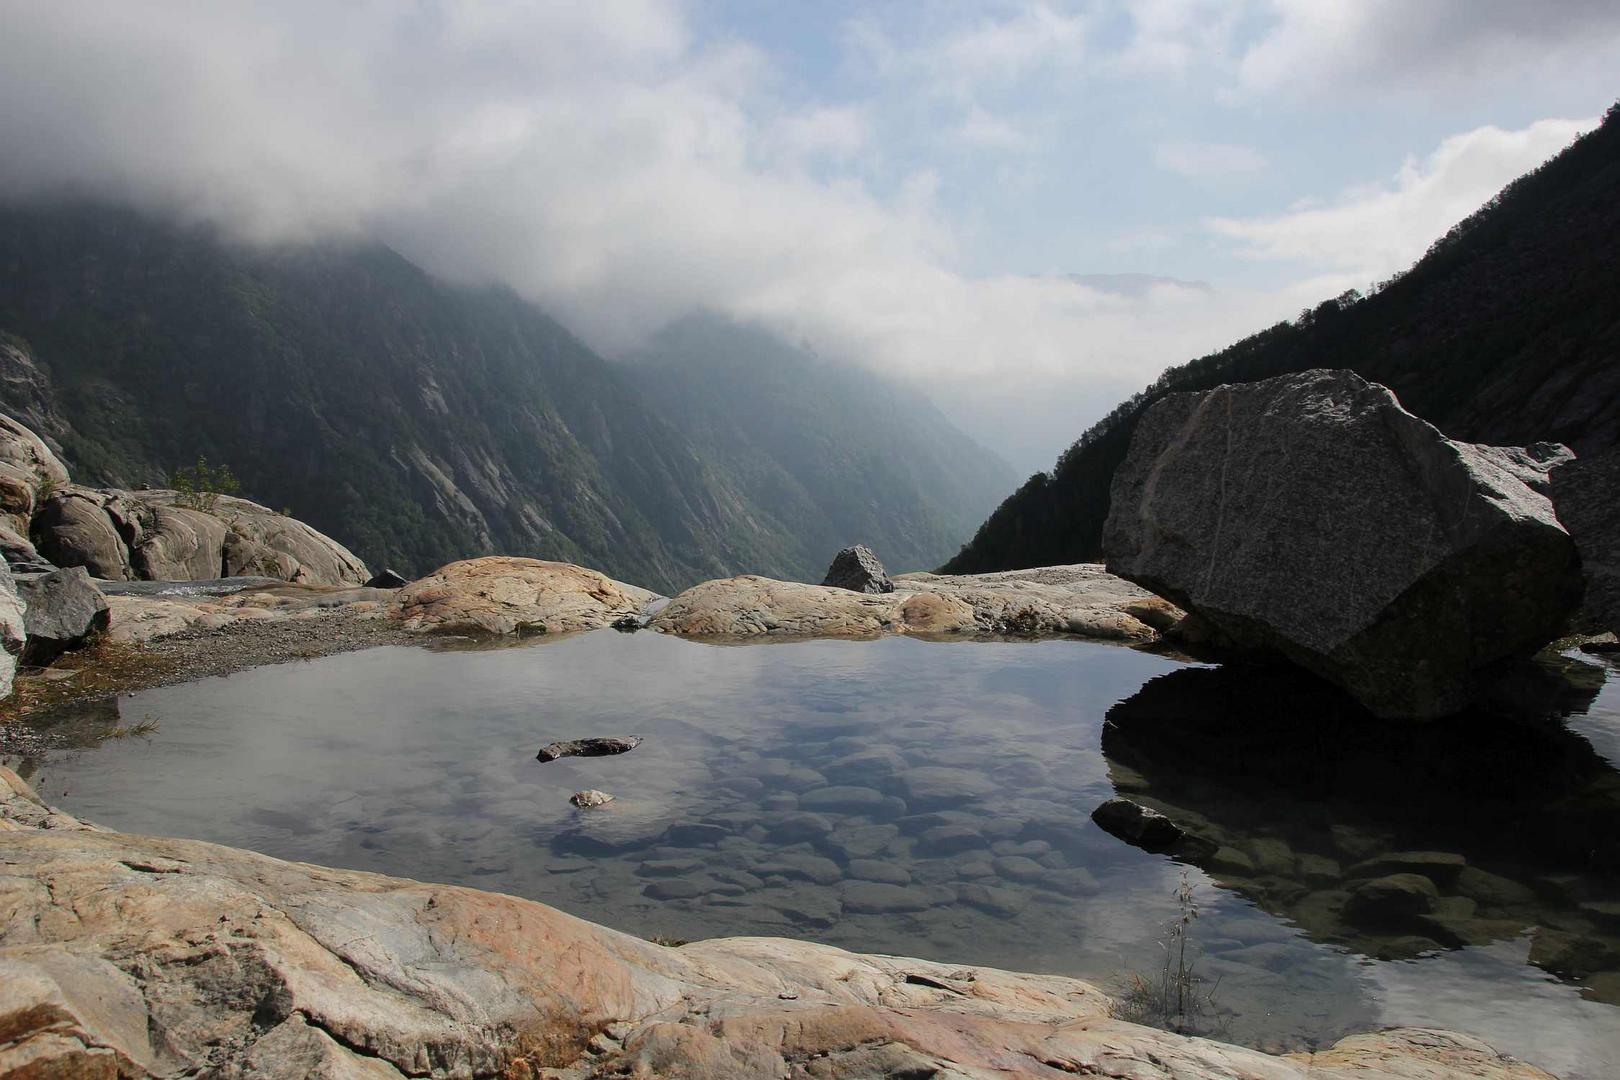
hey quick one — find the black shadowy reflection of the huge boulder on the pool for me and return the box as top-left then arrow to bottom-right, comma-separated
1102,661 -> 1620,1004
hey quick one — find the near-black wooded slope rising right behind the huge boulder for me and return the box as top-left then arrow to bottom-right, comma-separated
944,105 -> 1620,573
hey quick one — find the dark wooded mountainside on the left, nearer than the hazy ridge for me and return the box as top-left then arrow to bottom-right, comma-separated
0,204 -> 997,591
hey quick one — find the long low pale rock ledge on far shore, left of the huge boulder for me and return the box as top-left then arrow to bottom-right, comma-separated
650,565 -> 1181,643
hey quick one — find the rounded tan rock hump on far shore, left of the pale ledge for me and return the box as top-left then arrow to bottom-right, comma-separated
389,555 -> 658,635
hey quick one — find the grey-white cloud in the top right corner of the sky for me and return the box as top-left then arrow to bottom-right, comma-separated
1238,0 -> 1620,94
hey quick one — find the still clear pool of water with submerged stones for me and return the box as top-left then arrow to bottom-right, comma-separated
8,631 -> 1620,1078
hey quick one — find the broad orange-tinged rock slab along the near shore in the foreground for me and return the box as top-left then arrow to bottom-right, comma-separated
0,769 -> 1547,1080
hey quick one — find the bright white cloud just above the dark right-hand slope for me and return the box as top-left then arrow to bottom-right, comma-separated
1209,118 -> 1597,283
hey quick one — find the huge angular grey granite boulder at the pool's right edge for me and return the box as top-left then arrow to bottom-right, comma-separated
1103,371 -> 1581,717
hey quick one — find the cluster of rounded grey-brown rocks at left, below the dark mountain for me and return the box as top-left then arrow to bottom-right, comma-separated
34,486 -> 371,585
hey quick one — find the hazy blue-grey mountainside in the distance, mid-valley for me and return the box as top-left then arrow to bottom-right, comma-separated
632,314 -> 1016,580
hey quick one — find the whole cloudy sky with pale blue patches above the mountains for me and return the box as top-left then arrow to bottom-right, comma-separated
0,0 -> 1620,473
